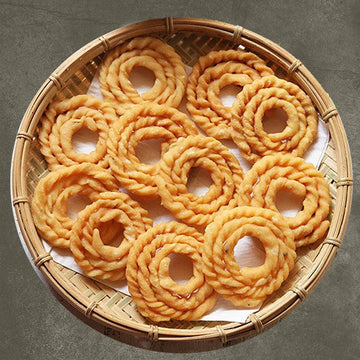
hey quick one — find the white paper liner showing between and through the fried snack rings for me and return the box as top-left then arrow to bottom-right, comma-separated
43,66 -> 329,323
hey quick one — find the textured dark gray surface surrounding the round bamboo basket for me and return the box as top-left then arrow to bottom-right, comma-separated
0,0 -> 360,360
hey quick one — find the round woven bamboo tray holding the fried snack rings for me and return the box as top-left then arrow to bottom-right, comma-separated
11,18 -> 353,352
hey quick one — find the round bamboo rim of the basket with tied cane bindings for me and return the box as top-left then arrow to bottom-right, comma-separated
10,17 -> 352,352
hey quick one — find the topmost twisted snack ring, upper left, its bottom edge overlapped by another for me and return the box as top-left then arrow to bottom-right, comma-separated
99,37 -> 187,115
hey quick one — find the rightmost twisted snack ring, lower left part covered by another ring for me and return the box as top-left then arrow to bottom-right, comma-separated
239,154 -> 331,247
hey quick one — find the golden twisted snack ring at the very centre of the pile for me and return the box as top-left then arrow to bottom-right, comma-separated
156,135 -> 243,226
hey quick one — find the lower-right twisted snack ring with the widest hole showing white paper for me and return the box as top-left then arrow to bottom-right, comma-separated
203,206 -> 296,307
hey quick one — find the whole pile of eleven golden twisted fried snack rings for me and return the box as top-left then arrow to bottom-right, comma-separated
32,37 -> 330,322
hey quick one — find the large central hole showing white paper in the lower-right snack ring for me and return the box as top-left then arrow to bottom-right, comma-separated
234,235 -> 265,267
